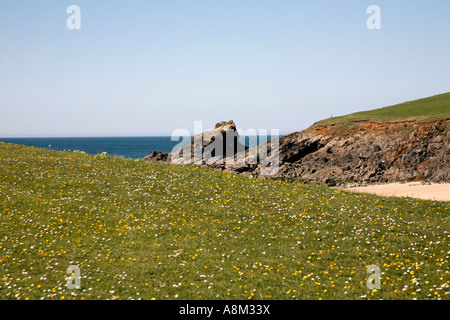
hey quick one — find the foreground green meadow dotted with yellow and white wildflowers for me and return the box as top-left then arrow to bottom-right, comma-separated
0,143 -> 450,299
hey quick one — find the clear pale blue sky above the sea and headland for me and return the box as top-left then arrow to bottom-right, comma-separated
0,0 -> 450,137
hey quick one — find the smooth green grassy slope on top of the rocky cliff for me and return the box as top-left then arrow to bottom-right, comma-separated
316,93 -> 450,125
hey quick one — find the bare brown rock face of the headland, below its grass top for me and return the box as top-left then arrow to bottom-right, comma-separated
146,119 -> 450,185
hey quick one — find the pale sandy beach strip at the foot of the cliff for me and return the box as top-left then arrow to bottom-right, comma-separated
344,182 -> 450,201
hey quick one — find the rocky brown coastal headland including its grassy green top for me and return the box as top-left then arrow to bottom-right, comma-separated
145,92 -> 450,185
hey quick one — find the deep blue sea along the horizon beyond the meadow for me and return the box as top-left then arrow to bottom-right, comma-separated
0,136 -> 278,159
